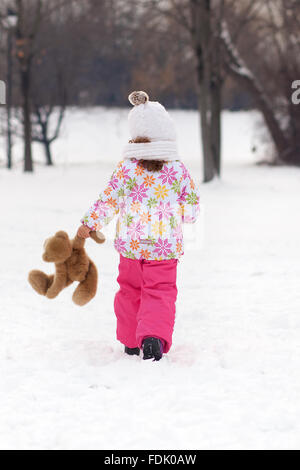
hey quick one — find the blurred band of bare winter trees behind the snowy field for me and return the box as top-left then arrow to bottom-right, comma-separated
0,0 -> 300,177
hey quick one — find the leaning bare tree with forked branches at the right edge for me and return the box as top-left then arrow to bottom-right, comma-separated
221,0 -> 300,164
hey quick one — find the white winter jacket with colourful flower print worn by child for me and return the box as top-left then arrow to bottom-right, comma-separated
81,159 -> 199,260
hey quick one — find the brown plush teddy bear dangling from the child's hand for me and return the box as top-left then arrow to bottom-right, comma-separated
28,231 -> 105,305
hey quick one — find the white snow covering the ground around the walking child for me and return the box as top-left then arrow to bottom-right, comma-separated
0,109 -> 300,449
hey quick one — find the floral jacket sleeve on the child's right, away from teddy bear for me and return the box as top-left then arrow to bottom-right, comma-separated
178,163 -> 200,224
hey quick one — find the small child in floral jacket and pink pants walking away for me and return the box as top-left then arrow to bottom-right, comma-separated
78,91 -> 199,361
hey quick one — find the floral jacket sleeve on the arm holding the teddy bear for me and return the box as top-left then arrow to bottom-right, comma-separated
81,162 -> 123,231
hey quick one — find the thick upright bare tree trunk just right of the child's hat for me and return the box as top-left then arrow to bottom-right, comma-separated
151,0 -> 224,182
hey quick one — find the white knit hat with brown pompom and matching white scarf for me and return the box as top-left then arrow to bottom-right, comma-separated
123,91 -> 179,160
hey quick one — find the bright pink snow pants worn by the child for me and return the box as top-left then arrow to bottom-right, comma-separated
114,255 -> 178,353
